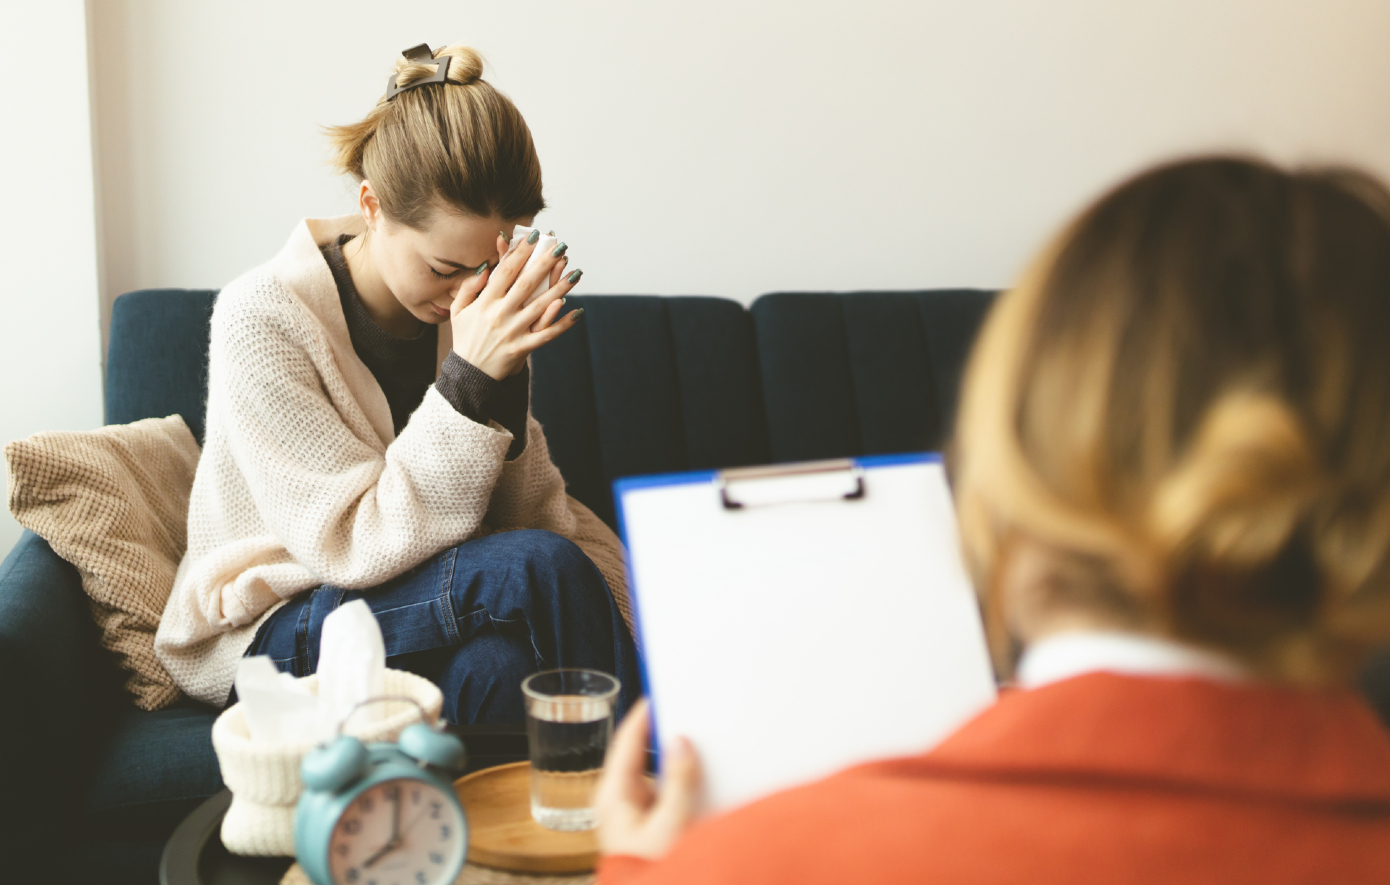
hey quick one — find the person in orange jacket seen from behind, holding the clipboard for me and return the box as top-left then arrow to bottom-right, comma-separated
598,158 -> 1390,885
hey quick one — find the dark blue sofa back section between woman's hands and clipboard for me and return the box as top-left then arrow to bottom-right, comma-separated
531,295 -> 769,525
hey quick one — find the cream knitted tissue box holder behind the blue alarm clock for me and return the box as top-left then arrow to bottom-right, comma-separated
213,670 -> 443,857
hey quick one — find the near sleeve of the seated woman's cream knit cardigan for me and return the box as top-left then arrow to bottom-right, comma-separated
219,287 -> 510,588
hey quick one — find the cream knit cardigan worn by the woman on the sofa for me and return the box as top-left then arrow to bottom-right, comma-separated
154,215 -> 631,707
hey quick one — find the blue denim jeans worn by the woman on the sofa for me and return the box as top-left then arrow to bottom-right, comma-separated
246,529 -> 641,724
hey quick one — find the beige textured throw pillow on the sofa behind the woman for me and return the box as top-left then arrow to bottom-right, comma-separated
4,415 -> 199,710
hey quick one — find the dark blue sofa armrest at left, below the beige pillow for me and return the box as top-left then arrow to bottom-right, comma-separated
0,532 -> 108,842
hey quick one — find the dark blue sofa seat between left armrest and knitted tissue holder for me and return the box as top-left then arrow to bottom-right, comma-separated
85,700 -> 222,839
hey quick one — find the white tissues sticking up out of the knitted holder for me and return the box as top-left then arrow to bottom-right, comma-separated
236,599 -> 386,743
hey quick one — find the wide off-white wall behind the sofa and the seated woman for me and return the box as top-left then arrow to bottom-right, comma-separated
96,0 -> 1390,343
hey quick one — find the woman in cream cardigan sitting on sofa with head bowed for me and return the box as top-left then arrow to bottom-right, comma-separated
156,46 -> 638,722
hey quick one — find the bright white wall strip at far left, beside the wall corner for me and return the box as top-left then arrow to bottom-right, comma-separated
0,0 -> 101,557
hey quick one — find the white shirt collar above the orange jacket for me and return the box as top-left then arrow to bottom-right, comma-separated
1015,631 -> 1250,689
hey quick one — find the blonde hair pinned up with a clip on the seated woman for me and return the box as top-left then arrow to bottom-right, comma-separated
327,46 -> 545,229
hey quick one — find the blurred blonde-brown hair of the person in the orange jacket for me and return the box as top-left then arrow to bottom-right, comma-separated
952,158 -> 1390,685
